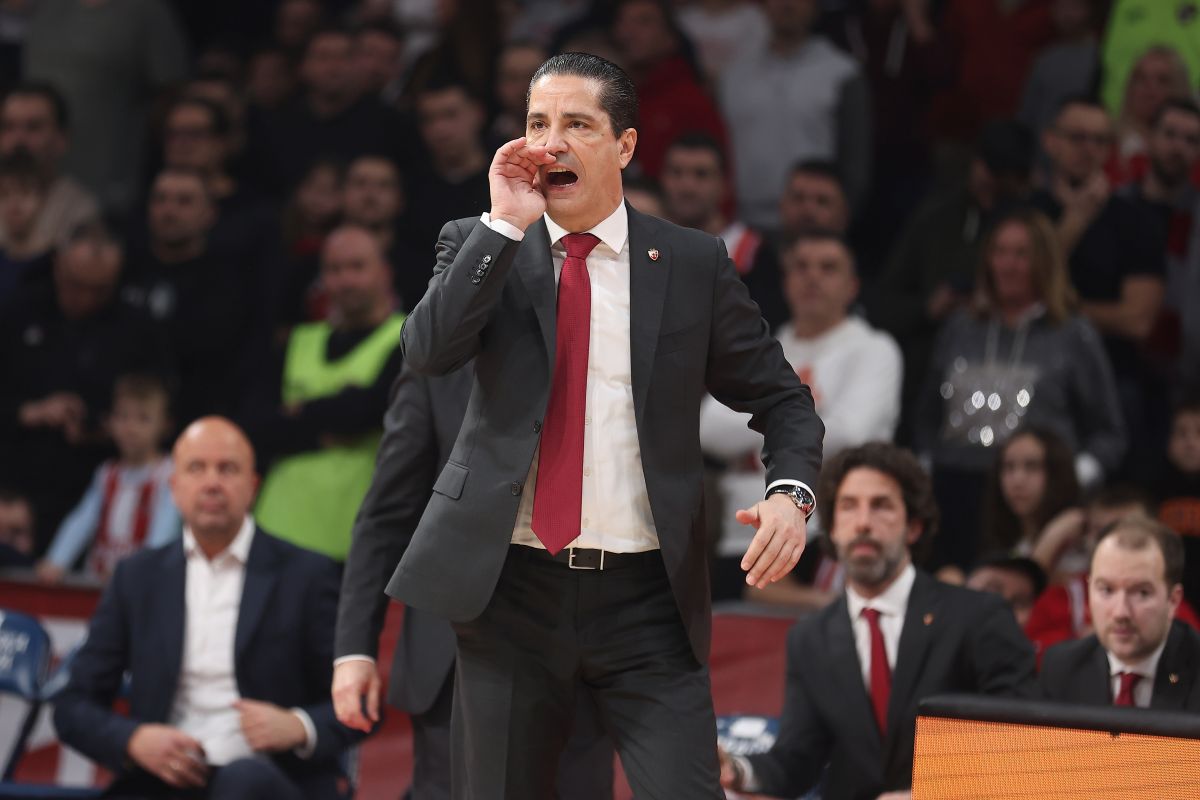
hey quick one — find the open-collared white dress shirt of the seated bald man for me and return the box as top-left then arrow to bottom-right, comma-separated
168,516 -> 317,766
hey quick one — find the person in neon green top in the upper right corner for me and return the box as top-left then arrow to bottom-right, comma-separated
1100,0 -> 1200,116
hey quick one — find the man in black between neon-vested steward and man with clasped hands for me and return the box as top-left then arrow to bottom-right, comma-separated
122,168 -> 262,425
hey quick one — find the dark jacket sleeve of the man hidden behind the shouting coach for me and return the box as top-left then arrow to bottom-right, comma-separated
334,366 -> 438,658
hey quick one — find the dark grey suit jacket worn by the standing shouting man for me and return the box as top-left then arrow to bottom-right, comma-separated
388,206 -> 824,662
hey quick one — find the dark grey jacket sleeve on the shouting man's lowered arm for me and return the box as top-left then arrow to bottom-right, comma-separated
706,239 -> 824,487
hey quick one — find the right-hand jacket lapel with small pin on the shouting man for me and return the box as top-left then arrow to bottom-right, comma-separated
625,203 -> 671,421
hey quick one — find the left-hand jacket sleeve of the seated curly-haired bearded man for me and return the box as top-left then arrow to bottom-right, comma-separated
749,626 -> 833,798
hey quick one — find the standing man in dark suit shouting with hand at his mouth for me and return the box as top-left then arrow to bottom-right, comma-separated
388,54 -> 823,800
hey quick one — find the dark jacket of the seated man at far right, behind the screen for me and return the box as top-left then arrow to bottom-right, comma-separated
1040,619 -> 1200,711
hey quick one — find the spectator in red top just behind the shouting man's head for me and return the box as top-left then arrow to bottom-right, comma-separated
612,0 -> 725,180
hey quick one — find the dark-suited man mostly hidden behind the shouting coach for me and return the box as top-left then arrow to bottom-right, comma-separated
332,366 -> 612,800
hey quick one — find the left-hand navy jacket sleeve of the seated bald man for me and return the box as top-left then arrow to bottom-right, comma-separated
54,564 -> 138,772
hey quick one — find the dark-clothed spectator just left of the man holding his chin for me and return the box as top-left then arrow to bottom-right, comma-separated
866,122 -> 1034,441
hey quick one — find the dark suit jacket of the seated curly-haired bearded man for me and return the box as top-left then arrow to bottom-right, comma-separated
750,571 -> 1037,800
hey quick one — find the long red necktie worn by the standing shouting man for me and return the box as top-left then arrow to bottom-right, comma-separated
530,234 -> 600,554
